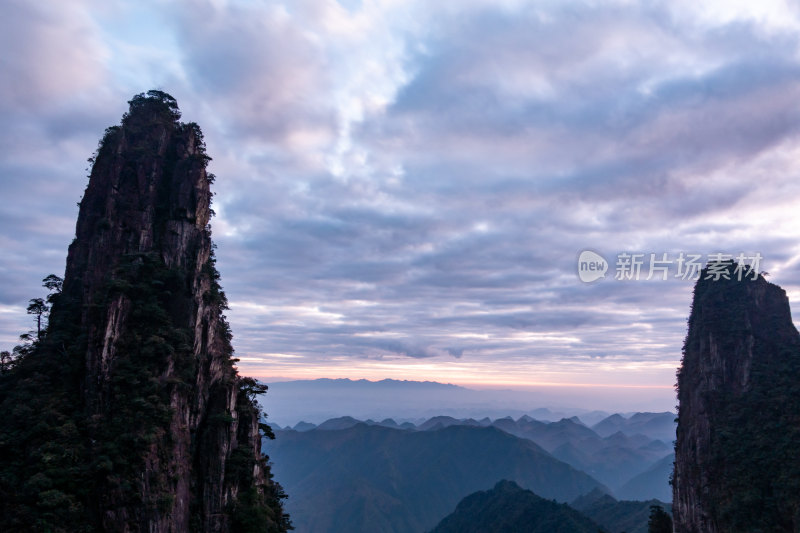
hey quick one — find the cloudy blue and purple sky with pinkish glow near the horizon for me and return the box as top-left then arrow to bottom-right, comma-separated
0,0 -> 800,408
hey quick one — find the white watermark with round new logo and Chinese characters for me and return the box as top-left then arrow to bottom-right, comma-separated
577,250 -> 766,283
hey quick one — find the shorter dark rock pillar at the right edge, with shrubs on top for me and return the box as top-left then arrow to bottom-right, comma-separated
673,263 -> 800,533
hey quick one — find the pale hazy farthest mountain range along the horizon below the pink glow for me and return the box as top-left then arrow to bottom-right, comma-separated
264,379 -> 674,426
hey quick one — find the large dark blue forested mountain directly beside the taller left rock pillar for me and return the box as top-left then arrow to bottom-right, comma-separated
264,419 -> 609,533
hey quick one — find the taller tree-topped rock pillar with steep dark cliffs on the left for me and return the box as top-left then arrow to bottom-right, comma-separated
0,91 -> 291,533
